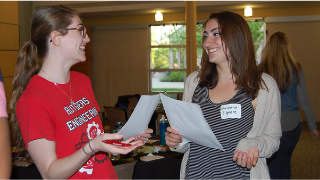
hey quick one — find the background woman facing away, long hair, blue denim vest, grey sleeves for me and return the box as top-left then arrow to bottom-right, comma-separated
259,31 -> 319,179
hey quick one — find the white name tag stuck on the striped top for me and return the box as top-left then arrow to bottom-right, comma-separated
220,104 -> 241,119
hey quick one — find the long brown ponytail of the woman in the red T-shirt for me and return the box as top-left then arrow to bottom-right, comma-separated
9,5 -> 78,146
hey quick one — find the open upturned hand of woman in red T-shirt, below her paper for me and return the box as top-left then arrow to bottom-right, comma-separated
90,133 -> 143,154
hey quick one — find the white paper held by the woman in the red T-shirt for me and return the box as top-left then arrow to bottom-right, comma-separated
119,95 -> 160,140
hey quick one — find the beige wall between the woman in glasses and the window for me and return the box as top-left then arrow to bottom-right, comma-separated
90,28 -> 148,111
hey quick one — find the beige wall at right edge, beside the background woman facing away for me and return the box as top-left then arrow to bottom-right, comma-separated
267,21 -> 320,121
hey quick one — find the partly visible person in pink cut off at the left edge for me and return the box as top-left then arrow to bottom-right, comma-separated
0,67 -> 12,179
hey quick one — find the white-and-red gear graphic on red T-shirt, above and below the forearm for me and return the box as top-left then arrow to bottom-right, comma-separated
79,122 -> 102,174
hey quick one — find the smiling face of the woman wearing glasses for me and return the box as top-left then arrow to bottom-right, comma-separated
61,16 -> 90,63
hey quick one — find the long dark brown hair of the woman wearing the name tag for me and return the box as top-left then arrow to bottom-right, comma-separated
199,11 -> 265,99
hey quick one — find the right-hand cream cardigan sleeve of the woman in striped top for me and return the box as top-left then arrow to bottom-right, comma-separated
236,74 -> 282,158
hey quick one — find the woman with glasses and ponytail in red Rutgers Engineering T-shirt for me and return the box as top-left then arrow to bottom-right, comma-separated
10,5 -> 152,179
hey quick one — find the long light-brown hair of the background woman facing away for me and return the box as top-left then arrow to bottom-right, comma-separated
259,31 -> 301,93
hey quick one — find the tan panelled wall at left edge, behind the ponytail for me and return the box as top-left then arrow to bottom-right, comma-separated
0,1 -> 19,114
